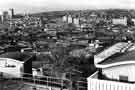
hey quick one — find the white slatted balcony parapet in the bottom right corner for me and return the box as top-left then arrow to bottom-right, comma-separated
87,72 -> 135,90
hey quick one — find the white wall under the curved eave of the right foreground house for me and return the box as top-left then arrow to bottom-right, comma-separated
102,64 -> 135,82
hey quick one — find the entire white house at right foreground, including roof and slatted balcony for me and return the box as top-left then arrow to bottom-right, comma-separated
87,42 -> 135,90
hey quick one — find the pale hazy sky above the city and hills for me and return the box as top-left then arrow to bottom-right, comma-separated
0,0 -> 135,13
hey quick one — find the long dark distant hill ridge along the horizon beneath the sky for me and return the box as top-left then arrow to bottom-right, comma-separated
31,9 -> 135,18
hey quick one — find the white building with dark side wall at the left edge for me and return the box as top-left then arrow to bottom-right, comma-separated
0,52 -> 32,78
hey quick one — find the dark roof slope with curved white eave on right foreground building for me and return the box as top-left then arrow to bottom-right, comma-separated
95,43 -> 135,68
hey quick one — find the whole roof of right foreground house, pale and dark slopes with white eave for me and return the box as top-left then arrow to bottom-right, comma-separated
95,43 -> 135,68
